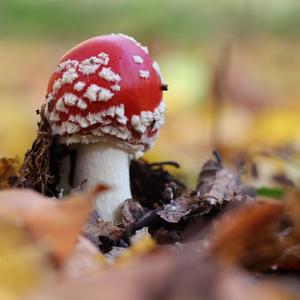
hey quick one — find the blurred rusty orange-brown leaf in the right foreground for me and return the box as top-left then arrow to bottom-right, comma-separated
210,201 -> 284,270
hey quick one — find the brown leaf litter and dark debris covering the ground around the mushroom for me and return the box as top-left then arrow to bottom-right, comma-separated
0,109 -> 300,300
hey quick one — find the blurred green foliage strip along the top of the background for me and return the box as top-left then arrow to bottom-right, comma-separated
0,0 -> 300,43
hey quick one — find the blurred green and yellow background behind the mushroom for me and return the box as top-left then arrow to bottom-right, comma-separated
0,0 -> 300,184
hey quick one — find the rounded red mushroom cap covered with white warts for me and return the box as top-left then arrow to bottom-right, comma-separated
45,34 -> 165,155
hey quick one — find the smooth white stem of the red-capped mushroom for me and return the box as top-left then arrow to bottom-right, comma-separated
74,142 -> 132,223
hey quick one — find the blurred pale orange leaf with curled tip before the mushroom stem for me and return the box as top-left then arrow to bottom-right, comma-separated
0,185 -> 107,264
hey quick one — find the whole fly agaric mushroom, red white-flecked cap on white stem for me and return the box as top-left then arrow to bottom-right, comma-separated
45,34 -> 167,222
